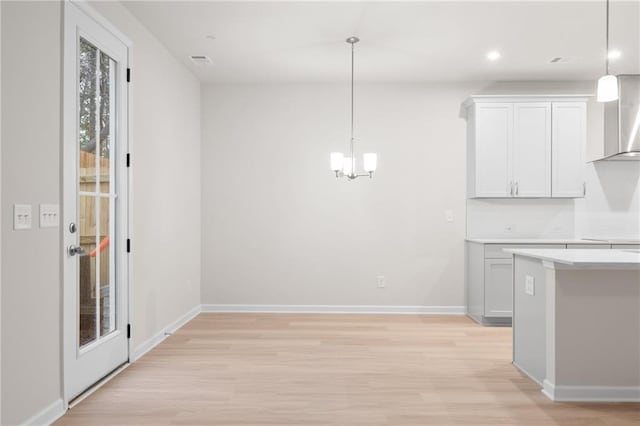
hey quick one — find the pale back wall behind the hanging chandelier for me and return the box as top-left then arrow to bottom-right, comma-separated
201,83 -> 480,306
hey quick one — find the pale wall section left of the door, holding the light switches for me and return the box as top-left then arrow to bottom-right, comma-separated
1,1 -> 62,425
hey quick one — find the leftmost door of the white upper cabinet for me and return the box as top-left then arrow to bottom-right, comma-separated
474,103 -> 513,197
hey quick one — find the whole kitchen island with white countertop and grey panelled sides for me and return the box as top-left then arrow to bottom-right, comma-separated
505,249 -> 640,401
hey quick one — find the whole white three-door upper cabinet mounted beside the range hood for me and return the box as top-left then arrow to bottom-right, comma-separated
467,97 -> 586,198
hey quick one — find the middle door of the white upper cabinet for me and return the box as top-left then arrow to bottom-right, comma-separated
513,102 -> 551,197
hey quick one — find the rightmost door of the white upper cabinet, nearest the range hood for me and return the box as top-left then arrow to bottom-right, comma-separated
551,102 -> 587,198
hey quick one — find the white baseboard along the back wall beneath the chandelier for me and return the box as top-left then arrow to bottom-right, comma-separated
202,304 -> 465,315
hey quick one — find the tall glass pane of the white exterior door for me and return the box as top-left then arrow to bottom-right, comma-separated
77,37 -> 117,348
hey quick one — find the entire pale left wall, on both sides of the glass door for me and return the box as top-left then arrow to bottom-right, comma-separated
0,1 -> 200,425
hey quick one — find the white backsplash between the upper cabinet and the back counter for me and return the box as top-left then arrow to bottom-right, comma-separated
467,161 -> 640,240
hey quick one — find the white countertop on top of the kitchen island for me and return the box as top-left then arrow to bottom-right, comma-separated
504,249 -> 640,268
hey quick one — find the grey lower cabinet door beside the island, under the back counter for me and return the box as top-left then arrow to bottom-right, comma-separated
484,259 -> 513,317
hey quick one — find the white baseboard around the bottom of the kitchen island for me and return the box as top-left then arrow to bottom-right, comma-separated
542,380 -> 640,402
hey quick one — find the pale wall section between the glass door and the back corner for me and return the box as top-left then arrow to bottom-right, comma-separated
92,2 -> 201,360
